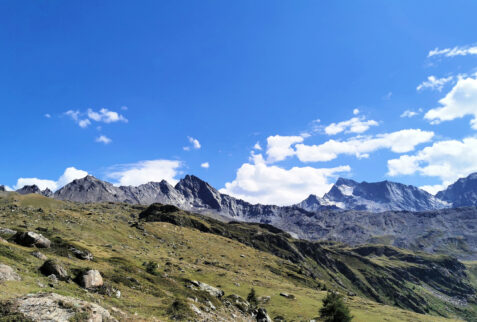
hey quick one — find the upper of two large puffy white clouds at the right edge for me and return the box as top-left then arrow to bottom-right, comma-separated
424,77 -> 477,130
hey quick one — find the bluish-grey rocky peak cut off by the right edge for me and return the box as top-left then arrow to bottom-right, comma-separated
436,173 -> 477,207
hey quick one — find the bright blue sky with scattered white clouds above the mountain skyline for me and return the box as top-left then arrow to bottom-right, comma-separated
0,1 -> 477,204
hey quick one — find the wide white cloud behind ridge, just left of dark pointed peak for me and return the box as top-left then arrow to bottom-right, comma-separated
107,160 -> 182,186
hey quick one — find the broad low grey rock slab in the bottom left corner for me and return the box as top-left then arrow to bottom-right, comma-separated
2,293 -> 117,322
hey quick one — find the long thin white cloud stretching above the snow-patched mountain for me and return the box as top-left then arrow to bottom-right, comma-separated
295,129 -> 434,162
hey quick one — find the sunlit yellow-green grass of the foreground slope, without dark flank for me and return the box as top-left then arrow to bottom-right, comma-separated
0,194 -> 464,321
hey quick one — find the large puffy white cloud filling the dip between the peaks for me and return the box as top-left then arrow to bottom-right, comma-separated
220,154 -> 350,205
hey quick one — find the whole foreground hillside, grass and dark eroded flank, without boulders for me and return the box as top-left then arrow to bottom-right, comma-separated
0,193 -> 477,321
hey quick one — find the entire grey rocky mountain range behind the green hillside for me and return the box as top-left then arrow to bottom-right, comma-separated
5,174 -> 477,259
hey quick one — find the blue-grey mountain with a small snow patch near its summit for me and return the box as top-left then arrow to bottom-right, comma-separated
323,178 -> 450,212
